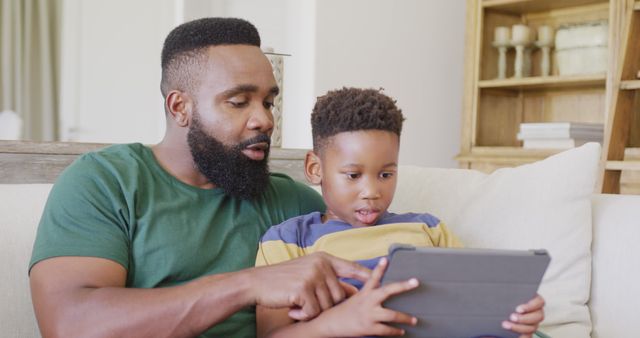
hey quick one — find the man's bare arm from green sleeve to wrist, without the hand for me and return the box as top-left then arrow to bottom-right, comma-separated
31,257 -> 252,337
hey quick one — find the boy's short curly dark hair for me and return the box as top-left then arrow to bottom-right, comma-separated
311,87 -> 404,151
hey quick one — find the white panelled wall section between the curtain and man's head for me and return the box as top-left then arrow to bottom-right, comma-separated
60,0 -> 176,143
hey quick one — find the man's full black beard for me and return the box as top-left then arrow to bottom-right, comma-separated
187,113 -> 271,200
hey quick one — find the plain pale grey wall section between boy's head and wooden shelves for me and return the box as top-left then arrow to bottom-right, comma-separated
315,0 -> 465,167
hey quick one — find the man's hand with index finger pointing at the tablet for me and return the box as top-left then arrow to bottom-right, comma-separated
250,252 -> 371,320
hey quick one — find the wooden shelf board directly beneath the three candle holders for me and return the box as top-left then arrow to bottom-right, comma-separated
478,73 -> 608,89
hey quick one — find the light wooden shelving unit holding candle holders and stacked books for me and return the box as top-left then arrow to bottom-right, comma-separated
457,0 -> 640,193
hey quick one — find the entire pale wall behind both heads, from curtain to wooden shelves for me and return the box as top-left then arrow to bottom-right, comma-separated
61,0 -> 465,167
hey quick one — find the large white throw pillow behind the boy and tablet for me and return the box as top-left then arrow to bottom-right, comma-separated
390,143 -> 600,337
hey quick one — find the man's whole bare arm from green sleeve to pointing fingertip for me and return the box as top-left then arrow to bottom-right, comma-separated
31,254 -> 370,337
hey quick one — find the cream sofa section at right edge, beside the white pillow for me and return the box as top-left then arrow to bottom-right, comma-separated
590,194 -> 640,338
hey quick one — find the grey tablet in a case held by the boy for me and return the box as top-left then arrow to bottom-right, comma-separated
382,244 -> 550,338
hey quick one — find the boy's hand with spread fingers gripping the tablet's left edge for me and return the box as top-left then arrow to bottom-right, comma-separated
310,258 -> 418,337
